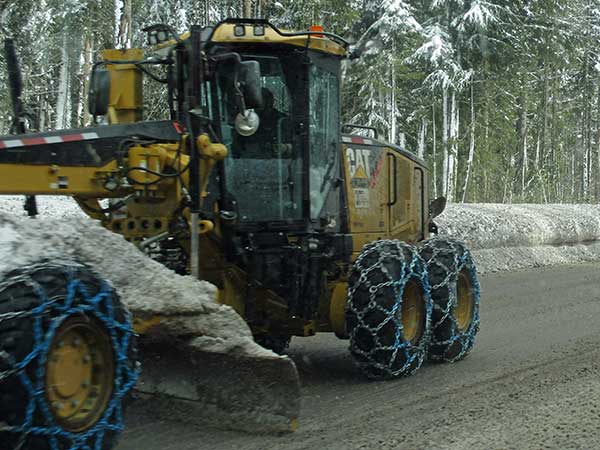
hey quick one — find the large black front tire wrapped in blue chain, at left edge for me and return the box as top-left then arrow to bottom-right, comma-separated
0,261 -> 139,450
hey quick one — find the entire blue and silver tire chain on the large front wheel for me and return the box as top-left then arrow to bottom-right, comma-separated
0,260 -> 141,450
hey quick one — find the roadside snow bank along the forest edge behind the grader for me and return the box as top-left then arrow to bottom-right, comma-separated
0,196 -> 600,273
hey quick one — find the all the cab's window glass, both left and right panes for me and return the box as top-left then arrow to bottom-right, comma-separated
217,52 -> 339,222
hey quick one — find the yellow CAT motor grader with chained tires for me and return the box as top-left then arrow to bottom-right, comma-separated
0,19 -> 479,450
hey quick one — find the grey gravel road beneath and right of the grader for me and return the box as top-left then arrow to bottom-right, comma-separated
118,264 -> 600,450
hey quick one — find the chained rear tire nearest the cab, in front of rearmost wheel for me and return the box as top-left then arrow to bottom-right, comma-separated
346,240 -> 432,379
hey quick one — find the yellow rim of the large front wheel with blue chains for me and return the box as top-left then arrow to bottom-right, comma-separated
46,317 -> 115,432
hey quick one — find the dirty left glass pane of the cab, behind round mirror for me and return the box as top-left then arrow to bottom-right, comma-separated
219,55 -> 302,221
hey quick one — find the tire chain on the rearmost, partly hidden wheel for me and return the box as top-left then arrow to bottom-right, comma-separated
420,236 -> 480,362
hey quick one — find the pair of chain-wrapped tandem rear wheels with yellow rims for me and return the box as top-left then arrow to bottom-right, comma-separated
346,237 -> 480,379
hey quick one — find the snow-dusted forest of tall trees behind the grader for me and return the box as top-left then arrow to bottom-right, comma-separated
0,0 -> 600,203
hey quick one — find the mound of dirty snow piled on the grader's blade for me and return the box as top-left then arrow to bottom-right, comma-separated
0,207 -> 277,358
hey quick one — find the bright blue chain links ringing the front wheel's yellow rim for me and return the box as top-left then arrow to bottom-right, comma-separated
1,268 -> 140,450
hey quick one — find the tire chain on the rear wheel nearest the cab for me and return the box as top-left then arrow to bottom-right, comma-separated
346,240 -> 432,378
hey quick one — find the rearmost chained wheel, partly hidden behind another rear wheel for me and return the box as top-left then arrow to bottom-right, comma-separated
420,237 -> 480,362
